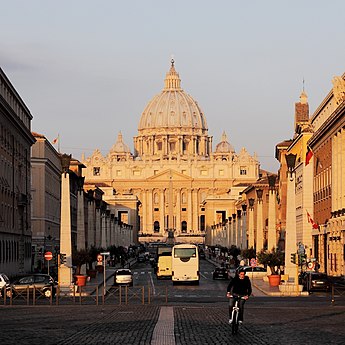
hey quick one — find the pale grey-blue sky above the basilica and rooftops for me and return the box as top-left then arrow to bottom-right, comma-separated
0,0 -> 345,172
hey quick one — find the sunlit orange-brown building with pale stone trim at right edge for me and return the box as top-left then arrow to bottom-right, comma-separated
309,74 -> 345,276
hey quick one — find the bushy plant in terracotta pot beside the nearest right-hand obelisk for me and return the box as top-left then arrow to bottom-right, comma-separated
257,248 -> 285,286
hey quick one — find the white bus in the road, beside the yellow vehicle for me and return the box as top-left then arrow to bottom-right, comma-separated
171,244 -> 199,284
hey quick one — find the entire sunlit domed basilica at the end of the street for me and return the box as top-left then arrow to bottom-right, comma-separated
82,61 -> 260,244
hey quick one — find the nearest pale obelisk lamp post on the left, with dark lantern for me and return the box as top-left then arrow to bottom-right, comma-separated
58,154 -> 72,287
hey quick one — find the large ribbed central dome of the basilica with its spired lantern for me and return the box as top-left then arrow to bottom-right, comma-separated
138,60 -> 207,135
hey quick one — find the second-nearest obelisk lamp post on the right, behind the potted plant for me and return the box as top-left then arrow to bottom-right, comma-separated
267,175 -> 277,250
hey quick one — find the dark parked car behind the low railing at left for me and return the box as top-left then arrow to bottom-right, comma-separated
7,274 -> 57,298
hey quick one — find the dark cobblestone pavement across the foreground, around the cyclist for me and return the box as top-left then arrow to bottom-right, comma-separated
0,298 -> 345,345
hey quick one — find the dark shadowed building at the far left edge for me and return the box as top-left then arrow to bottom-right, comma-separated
0,68 -> 35,276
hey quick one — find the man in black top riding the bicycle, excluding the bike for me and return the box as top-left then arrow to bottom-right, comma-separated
226,270 -> 252,325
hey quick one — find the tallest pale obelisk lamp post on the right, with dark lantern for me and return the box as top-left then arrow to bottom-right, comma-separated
285,153 -> 298,292
